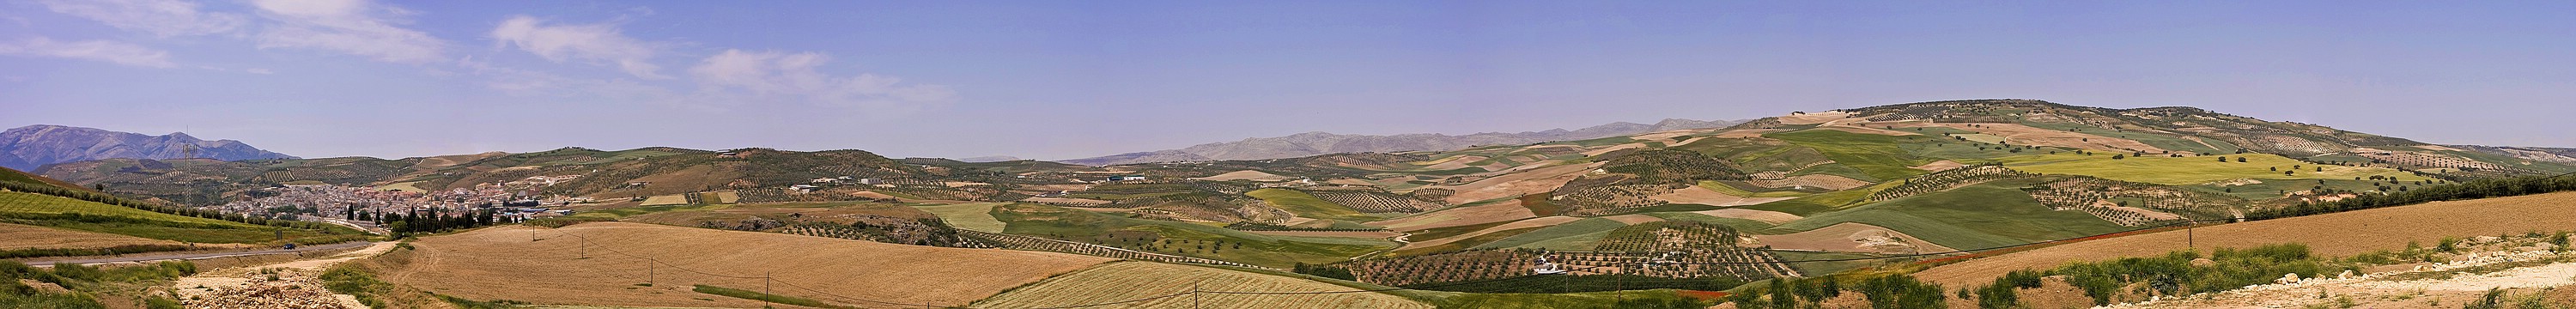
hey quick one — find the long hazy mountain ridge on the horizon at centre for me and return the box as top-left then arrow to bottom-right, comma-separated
1061,118 -> 1744,165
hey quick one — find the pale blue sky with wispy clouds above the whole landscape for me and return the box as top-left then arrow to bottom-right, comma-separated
0,0 -> 2576,160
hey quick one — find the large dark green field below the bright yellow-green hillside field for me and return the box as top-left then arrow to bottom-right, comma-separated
1762,178 -> 2133,250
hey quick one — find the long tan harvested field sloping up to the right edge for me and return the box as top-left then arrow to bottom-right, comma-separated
1914,193 -> 2576,286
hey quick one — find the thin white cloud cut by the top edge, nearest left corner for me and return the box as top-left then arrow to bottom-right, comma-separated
39,0 -> 245,36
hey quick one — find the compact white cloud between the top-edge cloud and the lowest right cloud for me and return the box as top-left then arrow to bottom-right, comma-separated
492,15 -> 665,80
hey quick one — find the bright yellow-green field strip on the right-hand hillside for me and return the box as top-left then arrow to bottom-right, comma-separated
1991,152 -> 2429,185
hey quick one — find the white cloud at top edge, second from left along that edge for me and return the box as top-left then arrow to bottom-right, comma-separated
252,0 -> 448,64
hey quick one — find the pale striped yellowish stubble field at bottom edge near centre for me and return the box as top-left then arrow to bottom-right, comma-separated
976,263 -> 1430,309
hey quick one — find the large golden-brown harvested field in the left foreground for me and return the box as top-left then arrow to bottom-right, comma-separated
381,221 -> 1108,306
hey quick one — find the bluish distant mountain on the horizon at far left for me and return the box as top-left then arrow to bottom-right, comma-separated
0,124 -> 291,170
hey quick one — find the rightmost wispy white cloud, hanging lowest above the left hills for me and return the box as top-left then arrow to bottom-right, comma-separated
688,49 -> 958,111
